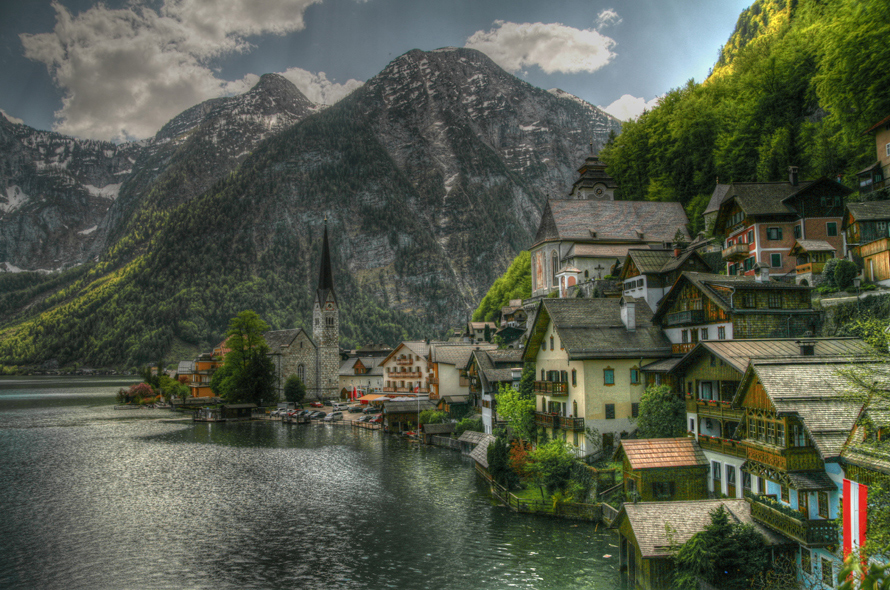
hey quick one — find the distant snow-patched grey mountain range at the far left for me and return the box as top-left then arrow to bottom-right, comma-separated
0,74 -> 319,270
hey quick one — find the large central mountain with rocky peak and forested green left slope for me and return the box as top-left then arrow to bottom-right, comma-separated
0,48 -> 620,365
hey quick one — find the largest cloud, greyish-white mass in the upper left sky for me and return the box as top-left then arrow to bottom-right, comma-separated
21,0 -> 322,140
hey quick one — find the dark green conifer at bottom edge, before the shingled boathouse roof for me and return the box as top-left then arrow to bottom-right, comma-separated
674,504 -> 771,590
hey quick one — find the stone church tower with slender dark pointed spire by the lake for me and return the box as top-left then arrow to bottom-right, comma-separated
312,218 -> 340,399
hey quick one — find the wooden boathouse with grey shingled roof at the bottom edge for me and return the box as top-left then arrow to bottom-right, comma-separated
614,499 -> 788,590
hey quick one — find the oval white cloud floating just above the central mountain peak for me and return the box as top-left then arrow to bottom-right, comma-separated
465,20 -> 615,74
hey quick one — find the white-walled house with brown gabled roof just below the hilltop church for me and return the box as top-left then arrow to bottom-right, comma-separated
618,244 -> 711,311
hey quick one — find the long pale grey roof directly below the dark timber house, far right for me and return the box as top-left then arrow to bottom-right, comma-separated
668,337 -> 874,373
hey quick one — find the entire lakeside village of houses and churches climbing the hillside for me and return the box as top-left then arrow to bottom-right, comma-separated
154,117 -> 890,589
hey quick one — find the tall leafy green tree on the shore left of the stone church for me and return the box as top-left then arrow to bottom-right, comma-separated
210,311 -> 276,405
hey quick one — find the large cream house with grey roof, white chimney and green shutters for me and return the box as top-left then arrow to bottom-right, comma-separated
523,297 -> 671,456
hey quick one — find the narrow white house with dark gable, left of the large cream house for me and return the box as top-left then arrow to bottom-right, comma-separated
465,350 -> 522,434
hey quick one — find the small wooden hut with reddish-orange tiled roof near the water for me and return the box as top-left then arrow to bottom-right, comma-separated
612,437 -> 708,502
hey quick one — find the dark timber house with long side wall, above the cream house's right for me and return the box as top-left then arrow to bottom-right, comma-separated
652,266 -> 822,354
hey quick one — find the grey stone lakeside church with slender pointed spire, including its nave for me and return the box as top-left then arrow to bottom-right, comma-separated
263,219 -> 340,400
